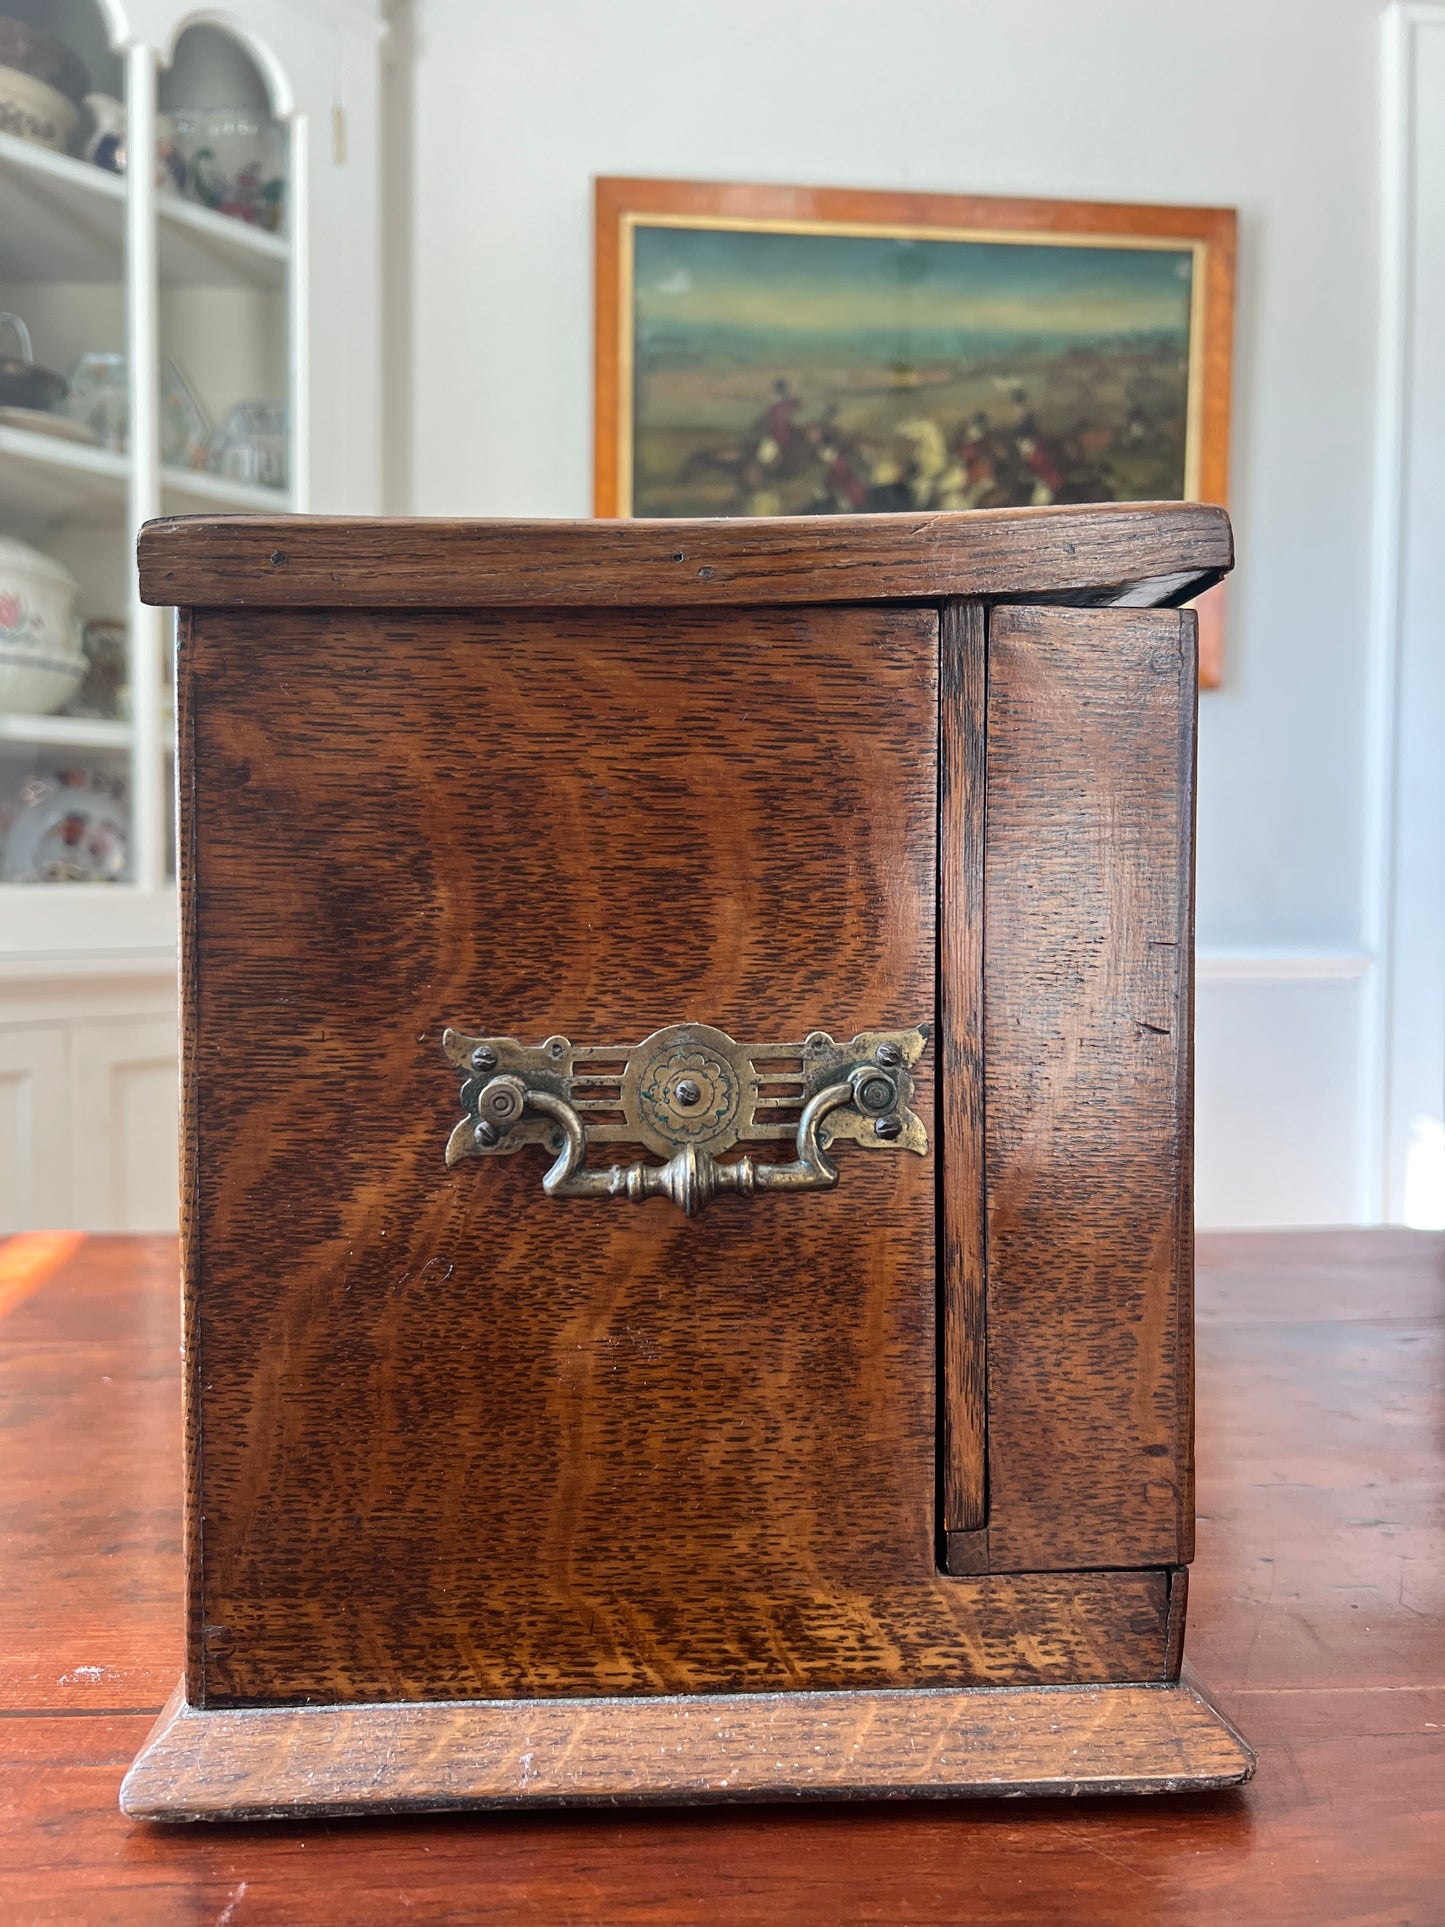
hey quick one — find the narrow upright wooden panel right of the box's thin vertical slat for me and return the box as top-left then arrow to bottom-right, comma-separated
985,609 -> 1195,1572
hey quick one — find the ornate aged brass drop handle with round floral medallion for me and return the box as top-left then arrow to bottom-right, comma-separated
441,1023 -> 929,1218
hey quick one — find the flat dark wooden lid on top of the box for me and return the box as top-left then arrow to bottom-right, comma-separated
139,501 -> 1233,609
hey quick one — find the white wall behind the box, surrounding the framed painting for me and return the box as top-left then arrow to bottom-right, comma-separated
402,0 -> 1418,1226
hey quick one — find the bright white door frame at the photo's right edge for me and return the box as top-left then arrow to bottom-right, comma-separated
1364,0 -> 1445,1227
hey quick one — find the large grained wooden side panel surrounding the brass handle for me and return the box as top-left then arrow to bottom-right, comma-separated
183,609 -> 963,1702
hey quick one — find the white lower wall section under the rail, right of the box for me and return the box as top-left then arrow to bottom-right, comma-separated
1195,965 -> 1366,1229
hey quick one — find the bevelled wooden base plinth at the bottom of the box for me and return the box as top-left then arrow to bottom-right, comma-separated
121,1680 -> 1254,1821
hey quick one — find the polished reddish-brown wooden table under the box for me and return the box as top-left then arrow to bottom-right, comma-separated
0,1231 -> 1445,1927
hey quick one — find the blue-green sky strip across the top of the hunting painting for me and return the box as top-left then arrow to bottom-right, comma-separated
634,225 -> 1193,339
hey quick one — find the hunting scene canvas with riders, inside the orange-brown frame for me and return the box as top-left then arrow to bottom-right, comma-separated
630,220 -> 1196,516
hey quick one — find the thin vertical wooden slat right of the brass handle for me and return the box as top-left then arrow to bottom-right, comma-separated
938,601 -> 988,1533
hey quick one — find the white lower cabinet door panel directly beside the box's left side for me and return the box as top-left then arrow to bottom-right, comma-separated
71,1017 -> 179,1231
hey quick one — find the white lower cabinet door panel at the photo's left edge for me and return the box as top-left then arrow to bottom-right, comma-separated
0,1023 -> 71,1231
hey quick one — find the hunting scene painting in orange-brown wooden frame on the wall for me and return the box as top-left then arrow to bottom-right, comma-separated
593,179 -> 1235,684
